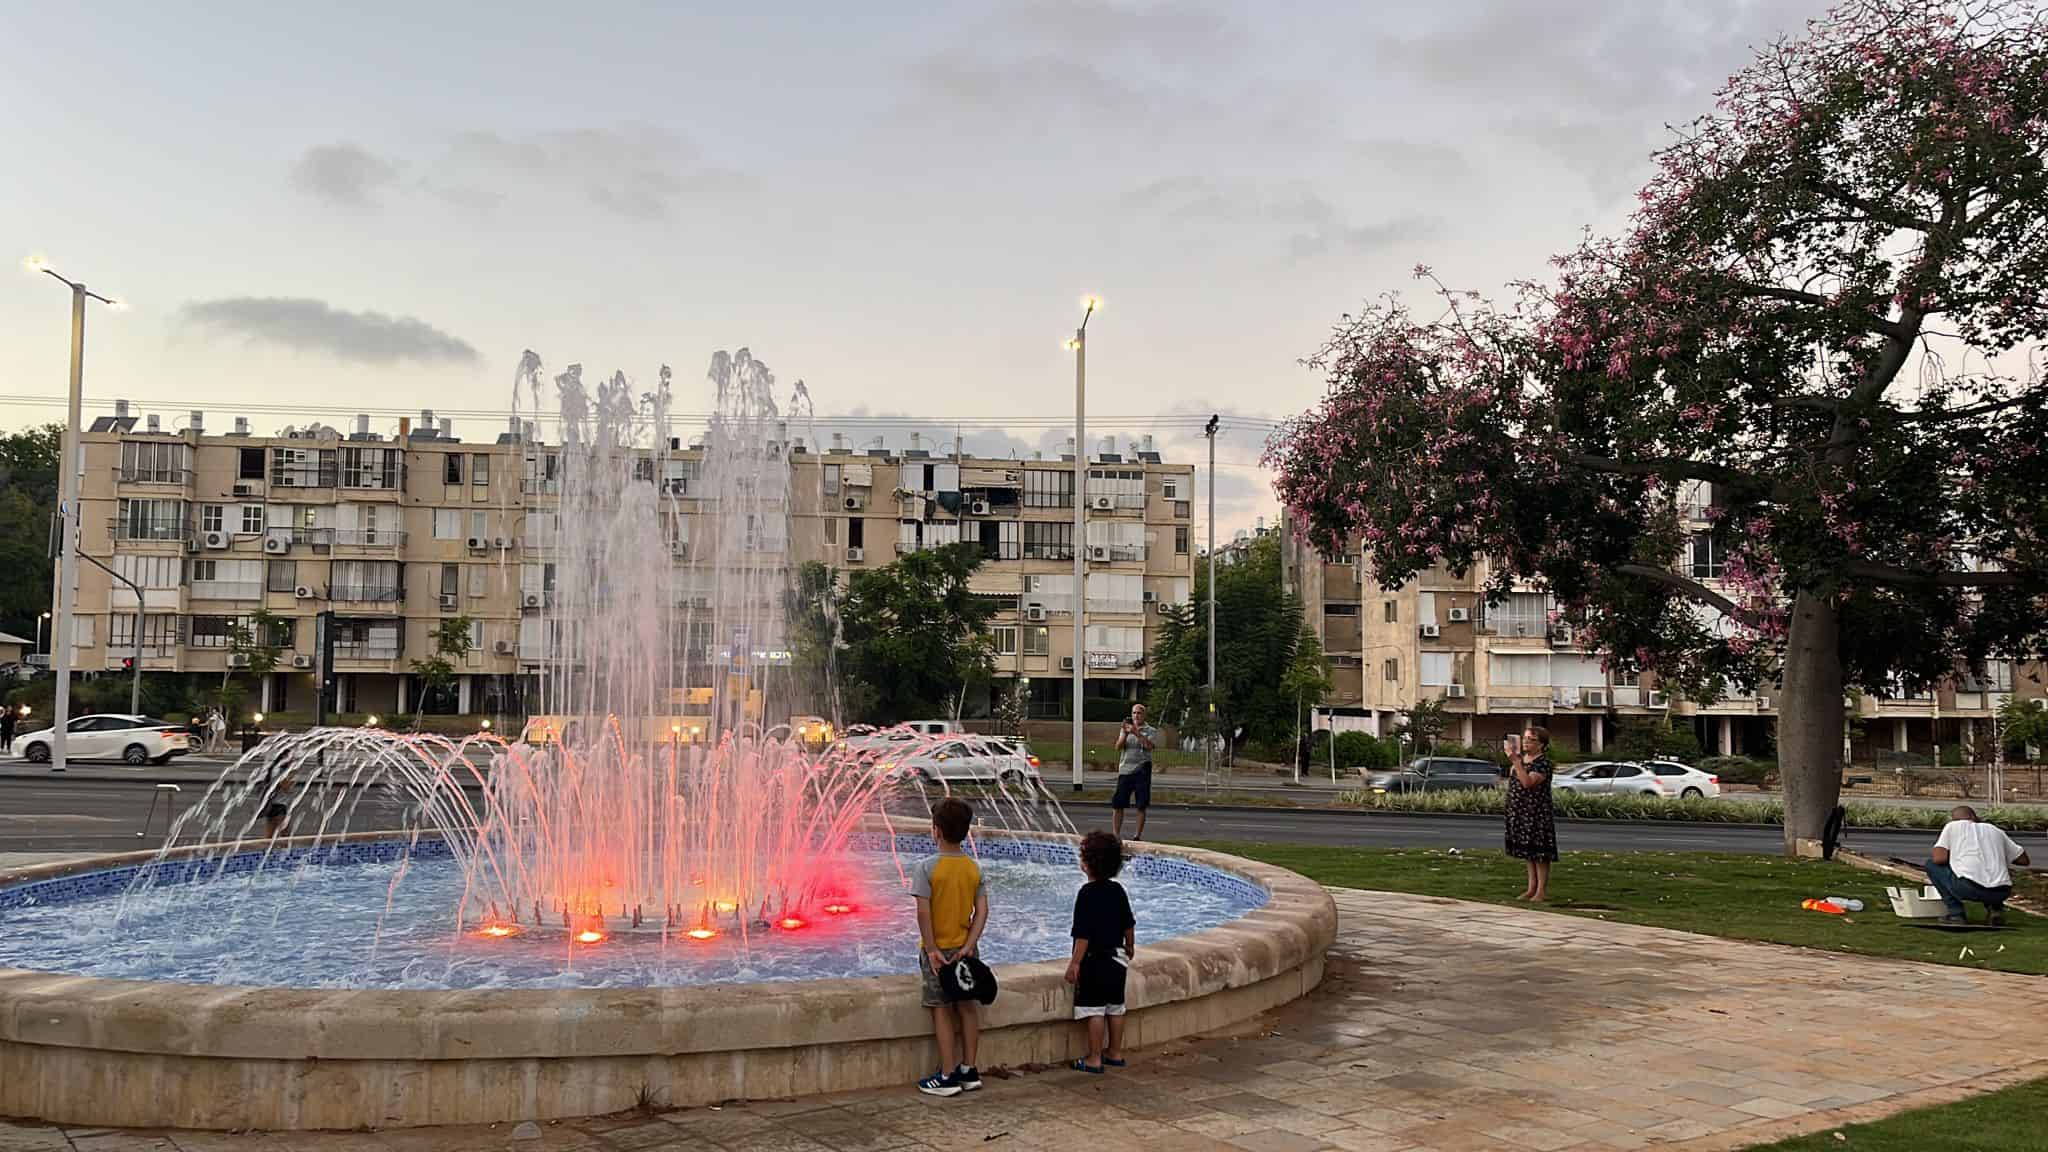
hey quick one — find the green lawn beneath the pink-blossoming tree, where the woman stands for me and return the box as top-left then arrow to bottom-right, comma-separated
1196,840 -> 2048,976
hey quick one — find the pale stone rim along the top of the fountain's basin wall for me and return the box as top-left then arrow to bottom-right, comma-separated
0,822 -> 1337,1060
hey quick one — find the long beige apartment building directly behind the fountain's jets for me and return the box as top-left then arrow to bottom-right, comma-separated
59,404 -> 1194,715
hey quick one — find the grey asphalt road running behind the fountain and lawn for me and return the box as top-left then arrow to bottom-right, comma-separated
0,775 -> 1933,859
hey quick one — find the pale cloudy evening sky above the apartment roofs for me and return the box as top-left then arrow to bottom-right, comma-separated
0,0 -> 1821,539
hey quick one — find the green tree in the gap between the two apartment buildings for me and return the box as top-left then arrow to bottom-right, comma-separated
1147,537 -> 1329,748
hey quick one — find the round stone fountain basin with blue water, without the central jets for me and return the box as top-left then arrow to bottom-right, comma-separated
0,832 -> 1337,1129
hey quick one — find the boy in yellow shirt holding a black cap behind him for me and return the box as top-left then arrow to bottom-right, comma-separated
909,797 -> 989,1097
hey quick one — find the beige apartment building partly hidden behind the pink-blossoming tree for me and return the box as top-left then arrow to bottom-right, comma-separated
1286,484 -> 2042,763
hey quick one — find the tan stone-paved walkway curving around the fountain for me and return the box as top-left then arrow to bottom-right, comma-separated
0,892 -> 2048,1152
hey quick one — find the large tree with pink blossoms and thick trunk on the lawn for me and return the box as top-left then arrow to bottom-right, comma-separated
1270,0 -> 2048,849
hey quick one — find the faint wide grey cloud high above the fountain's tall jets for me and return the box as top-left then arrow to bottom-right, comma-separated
426,127 -> 731,221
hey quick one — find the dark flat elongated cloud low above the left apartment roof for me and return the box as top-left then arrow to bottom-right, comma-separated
178,297 -> 477,365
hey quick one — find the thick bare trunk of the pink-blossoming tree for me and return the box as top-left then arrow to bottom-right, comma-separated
1778,592 -> 1843,855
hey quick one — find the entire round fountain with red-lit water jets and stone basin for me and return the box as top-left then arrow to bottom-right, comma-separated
0,351 -> 1335,1127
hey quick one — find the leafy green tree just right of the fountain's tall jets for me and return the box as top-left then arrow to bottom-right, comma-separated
838,543 -> 995,724
